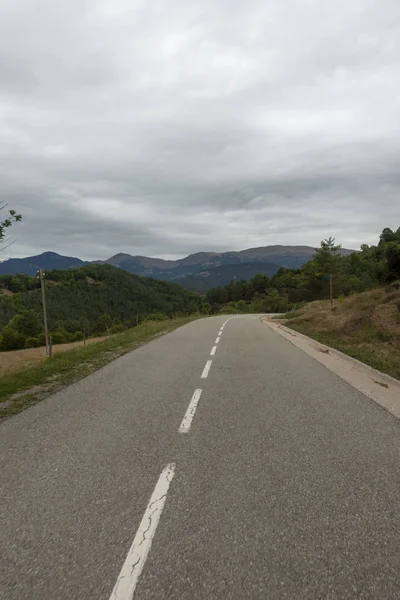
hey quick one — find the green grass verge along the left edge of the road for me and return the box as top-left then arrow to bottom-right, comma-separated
0,317 -> 198,420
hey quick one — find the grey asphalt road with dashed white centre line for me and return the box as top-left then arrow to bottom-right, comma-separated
0,316 -> 400,600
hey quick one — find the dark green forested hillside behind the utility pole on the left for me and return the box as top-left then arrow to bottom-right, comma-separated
0,265 -> 201,350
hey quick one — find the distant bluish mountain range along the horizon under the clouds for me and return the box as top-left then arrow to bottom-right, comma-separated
0,246 -> 353,292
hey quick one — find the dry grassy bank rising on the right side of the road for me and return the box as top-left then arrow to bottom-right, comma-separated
287,286 -> 400,379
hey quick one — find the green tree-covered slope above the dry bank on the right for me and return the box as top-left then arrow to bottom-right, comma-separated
207,228 -> 400,312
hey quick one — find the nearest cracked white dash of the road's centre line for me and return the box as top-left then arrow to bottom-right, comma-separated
110,463 -> 176,600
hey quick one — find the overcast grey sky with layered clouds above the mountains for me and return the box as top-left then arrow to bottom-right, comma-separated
0,0 -> 400,259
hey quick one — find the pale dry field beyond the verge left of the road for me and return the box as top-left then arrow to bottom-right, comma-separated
0,337 -> 106,377
